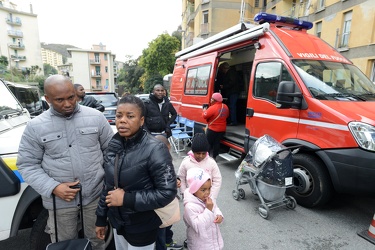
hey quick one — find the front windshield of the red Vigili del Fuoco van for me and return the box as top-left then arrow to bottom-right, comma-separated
292,60 -> 375,101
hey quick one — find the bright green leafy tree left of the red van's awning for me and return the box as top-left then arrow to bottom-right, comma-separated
139,33 -> 180,84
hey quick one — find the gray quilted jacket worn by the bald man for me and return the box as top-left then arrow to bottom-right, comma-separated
17,105 -> 113,209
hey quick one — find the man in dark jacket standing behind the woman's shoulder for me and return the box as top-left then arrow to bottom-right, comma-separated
144,84 -> 177,137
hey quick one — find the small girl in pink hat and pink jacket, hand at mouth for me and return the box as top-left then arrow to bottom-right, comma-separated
184,168 -> 224,250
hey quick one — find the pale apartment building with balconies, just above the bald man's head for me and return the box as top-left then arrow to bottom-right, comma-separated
67,44 -> 117,92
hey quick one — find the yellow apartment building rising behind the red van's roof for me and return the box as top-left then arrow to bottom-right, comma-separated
181,0 -> 375,82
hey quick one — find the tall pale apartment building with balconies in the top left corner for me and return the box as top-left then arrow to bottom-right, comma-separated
0,1 -> 43,74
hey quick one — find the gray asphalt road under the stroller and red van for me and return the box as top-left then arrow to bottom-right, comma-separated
0,147 -> 375,250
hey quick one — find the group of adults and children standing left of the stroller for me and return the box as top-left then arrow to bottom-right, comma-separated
17,75 -> 228,250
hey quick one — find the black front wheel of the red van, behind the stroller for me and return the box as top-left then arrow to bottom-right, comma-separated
286,153 -> 334,208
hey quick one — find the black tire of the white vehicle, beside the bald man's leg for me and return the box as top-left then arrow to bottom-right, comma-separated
30,209 -> 51,250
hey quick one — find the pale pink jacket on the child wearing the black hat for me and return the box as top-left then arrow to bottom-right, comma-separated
177,150 -> 222,200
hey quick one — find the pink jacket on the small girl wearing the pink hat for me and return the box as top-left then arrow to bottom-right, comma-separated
183,188 -> 224,250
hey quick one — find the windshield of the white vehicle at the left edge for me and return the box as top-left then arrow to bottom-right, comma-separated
0,81 -> 22,120
